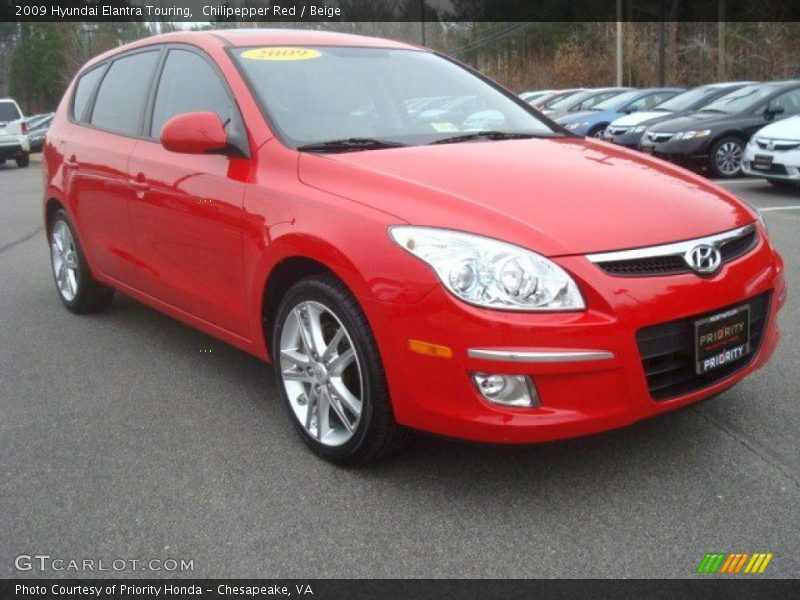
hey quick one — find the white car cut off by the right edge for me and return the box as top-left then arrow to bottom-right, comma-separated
742,116 -> 800,187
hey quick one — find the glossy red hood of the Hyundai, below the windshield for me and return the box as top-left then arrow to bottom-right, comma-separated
298,138 -> 754,256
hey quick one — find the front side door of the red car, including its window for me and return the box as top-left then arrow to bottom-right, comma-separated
128,47 -> 250,337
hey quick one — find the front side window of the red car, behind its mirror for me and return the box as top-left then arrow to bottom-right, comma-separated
150,50 -> 233,137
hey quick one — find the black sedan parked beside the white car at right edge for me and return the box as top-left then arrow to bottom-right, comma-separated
639,80 -> 800,178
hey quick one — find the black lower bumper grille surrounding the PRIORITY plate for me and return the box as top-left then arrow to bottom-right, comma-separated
636,292 -> 770,402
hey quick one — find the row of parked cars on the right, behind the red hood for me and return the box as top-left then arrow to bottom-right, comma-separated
520,80 -> 800,187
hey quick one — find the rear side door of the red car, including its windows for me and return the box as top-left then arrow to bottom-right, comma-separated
64,49 -> 161,284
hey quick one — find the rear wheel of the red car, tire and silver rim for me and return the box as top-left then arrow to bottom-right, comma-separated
47,209 -> 114,314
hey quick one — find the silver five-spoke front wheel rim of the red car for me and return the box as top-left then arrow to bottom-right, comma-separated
279,301 -> 364,446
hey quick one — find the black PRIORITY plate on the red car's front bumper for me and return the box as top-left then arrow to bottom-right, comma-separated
694,304 -> 751,375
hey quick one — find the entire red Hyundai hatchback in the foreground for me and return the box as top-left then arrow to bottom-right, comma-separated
44,30 -> 786,464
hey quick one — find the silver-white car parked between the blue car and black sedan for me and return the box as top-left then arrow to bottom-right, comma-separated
605,81 -> 757,148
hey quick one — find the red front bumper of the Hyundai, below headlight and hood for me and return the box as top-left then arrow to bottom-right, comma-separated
361,238 -> 786,443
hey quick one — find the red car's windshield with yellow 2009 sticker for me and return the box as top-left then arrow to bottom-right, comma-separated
232,46 -> 559,148
